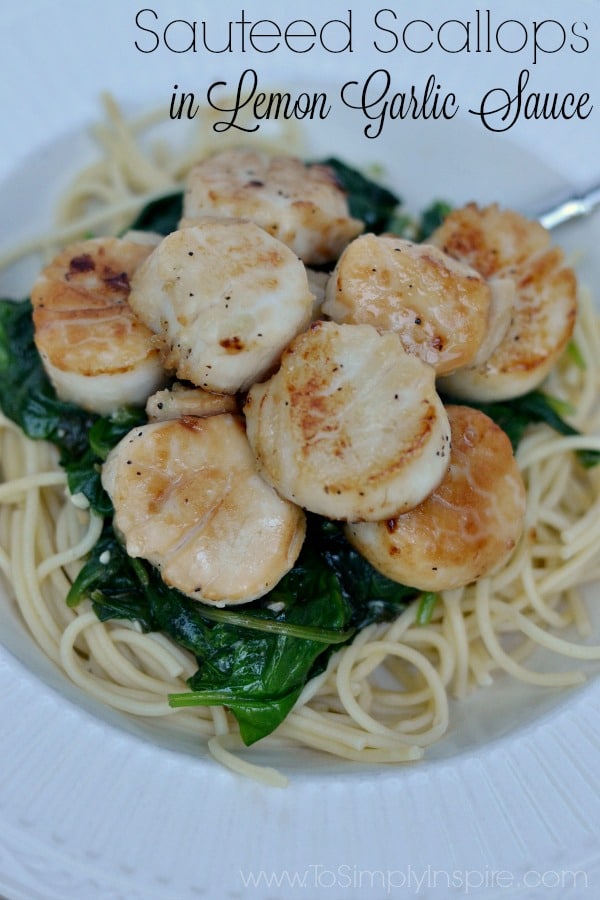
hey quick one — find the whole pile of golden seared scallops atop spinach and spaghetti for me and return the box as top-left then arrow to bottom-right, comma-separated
32,150 -> 576,606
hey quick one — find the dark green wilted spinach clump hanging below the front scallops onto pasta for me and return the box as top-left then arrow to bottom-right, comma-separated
67,516 -> 417,744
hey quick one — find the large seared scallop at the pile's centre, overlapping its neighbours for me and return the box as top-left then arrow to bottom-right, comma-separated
244,322 -> 450,521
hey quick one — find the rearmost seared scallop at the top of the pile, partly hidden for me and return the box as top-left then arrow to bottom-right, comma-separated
183,149 -> 363,265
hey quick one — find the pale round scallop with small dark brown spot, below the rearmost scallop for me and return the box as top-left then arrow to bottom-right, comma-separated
129,219 -> 314,394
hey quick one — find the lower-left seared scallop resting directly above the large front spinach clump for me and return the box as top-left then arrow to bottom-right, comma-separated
102,414 -> 306,606
